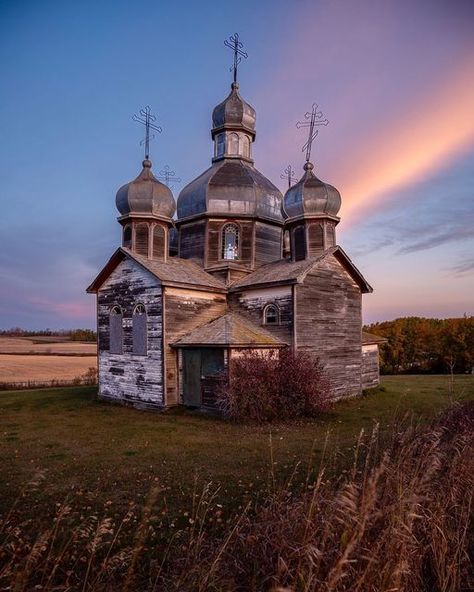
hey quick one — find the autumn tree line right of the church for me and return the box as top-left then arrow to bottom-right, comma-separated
364,315 -> 474,374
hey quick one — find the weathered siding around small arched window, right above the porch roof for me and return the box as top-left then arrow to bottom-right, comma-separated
229,286 -> 293,345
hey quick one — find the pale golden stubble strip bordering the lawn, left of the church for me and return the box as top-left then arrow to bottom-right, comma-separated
0,354 -> 96,382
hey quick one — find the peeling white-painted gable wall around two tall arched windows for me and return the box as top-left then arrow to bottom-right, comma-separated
97,259 -> 164,408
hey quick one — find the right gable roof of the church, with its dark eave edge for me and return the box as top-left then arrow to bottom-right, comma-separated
230,246 -> 373,293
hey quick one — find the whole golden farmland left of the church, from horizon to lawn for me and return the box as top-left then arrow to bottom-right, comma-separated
0,336 -> 97,382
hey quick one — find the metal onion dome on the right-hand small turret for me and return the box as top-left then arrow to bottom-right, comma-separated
283,162 -> 341,218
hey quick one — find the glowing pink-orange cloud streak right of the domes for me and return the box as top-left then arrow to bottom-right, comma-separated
338,56 -> 474,222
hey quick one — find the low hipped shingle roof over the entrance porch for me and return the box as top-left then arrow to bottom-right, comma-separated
171,312 -> 286,347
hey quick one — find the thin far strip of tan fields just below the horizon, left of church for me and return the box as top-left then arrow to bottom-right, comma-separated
0,336 -> 97,356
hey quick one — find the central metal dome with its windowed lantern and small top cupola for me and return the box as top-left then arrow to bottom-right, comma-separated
178,82 -> 283,223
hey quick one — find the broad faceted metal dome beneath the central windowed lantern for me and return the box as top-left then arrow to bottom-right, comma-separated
178,159 -> 282,222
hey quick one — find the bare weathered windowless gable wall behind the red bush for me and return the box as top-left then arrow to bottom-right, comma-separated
295,256 -> 362,398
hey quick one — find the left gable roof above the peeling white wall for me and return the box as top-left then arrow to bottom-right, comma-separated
87,247 -> 226,293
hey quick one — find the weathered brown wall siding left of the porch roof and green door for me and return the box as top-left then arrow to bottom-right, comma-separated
164,288 -> 227,405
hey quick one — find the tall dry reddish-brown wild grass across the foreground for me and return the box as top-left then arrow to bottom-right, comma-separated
0,401 -> 474,592
